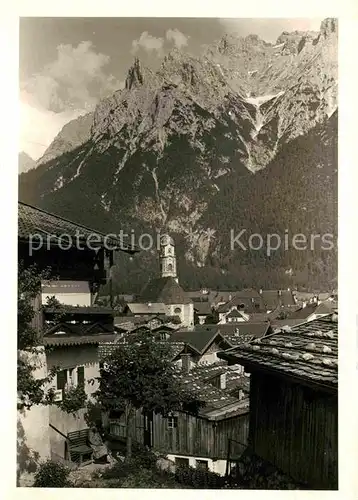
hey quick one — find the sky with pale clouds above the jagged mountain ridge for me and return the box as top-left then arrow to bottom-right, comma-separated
19,17 -> 321,160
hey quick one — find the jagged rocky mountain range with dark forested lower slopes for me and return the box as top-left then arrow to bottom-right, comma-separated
19,19 -> 338,292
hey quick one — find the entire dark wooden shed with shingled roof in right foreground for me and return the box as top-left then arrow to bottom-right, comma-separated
219,315 -> 338,490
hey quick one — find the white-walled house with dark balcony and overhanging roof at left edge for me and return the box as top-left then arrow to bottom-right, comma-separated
18,203 -> 137,477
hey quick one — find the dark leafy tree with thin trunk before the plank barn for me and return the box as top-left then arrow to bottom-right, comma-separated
95,332 -> 202,459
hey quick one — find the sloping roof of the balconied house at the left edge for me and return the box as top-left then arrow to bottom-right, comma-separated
18,202 -> 138,254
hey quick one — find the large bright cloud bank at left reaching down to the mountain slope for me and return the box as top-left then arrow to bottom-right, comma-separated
20,42 -> 122,159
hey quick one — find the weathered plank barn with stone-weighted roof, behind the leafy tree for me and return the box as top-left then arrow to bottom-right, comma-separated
108,363 -> 249,475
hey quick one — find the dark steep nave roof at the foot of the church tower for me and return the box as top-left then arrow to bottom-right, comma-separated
138,276 -> 192,304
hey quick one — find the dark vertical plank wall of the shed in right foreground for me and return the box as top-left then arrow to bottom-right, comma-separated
249,373 -> 338,489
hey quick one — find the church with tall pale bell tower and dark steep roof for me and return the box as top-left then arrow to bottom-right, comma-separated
138,235 -> 194,328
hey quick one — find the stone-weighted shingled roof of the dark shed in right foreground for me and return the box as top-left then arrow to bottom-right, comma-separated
218,315 -> 338,391
